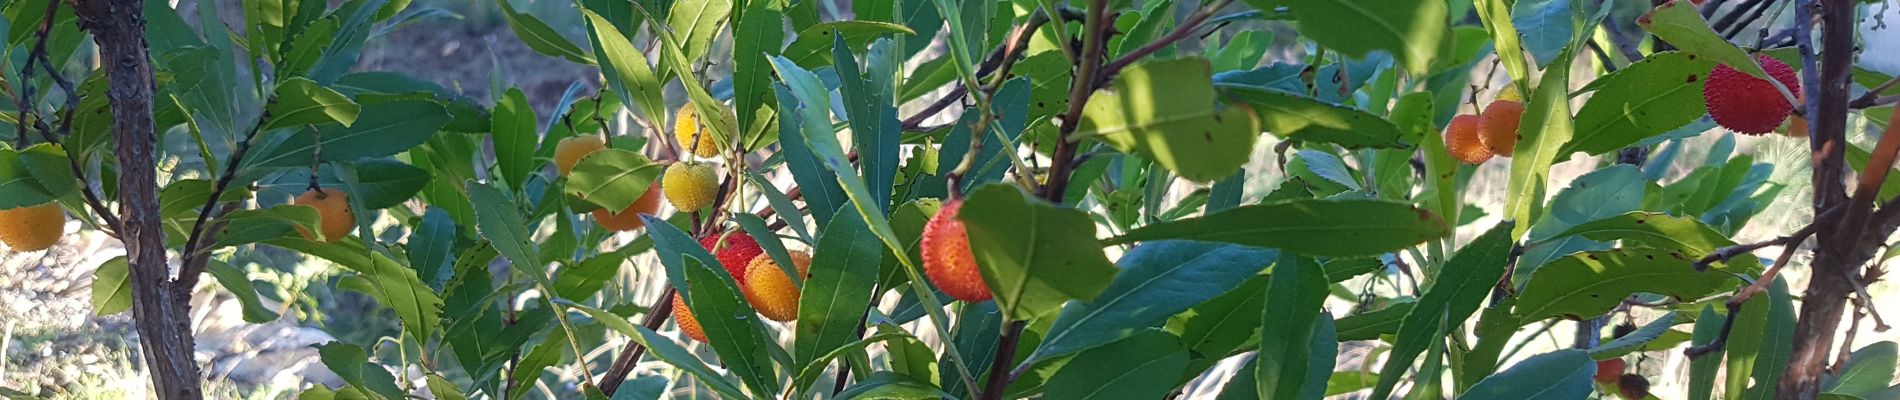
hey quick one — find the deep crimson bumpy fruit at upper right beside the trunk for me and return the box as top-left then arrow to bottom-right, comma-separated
1702,55 -> 1801,135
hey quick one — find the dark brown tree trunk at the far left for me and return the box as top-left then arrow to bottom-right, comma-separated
72,0 -> 203,400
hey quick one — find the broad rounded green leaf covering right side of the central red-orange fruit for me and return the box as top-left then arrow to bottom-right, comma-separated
958,184 -> 1115,320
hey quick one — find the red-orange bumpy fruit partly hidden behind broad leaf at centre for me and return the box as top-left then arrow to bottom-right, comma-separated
922,201 -> 990,301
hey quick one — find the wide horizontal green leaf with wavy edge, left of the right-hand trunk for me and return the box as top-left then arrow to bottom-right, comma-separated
1516,248 -> 1735,320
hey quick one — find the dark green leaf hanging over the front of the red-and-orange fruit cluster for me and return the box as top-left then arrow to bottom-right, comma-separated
684,258 -> 779,396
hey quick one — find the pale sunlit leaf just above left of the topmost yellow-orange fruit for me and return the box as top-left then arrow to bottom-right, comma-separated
583,9 -> 667,121
